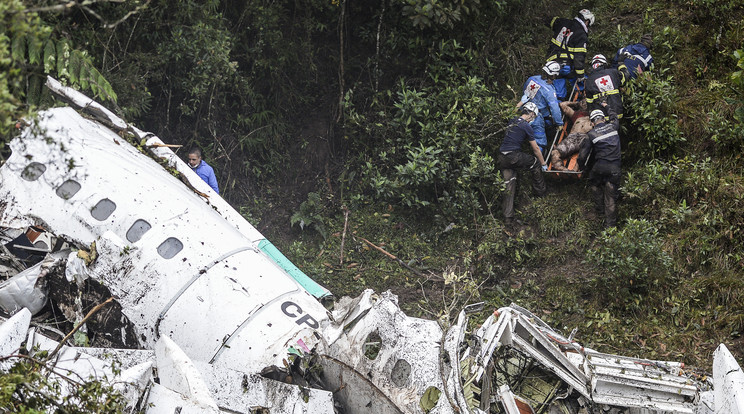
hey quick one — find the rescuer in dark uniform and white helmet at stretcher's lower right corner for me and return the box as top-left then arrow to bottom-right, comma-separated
579,102 -> 621,228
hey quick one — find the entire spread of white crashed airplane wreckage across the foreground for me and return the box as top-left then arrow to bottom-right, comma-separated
0,78 -> 744,414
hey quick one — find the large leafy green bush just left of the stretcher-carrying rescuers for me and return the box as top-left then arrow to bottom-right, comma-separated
346,41 -> 508,222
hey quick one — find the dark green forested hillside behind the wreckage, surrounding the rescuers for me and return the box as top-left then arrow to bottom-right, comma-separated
0,0 -> 744,369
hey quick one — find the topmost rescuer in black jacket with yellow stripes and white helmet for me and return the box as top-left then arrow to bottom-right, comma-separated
548,9 -> 594,101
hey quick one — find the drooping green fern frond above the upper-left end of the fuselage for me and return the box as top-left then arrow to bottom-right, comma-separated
11,34 -> 117,105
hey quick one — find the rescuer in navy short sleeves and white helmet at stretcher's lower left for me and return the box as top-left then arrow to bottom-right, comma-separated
498,102 -> 547,227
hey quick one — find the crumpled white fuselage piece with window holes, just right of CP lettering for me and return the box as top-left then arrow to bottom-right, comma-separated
318,292 -> 453,413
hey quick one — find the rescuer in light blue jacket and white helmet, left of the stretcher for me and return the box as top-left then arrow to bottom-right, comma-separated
517,62 -> 563,155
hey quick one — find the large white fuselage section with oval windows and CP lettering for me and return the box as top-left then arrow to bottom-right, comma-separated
0,104 -> 326,372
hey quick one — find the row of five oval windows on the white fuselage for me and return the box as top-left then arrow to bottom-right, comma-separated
21,162 -> 183,259
